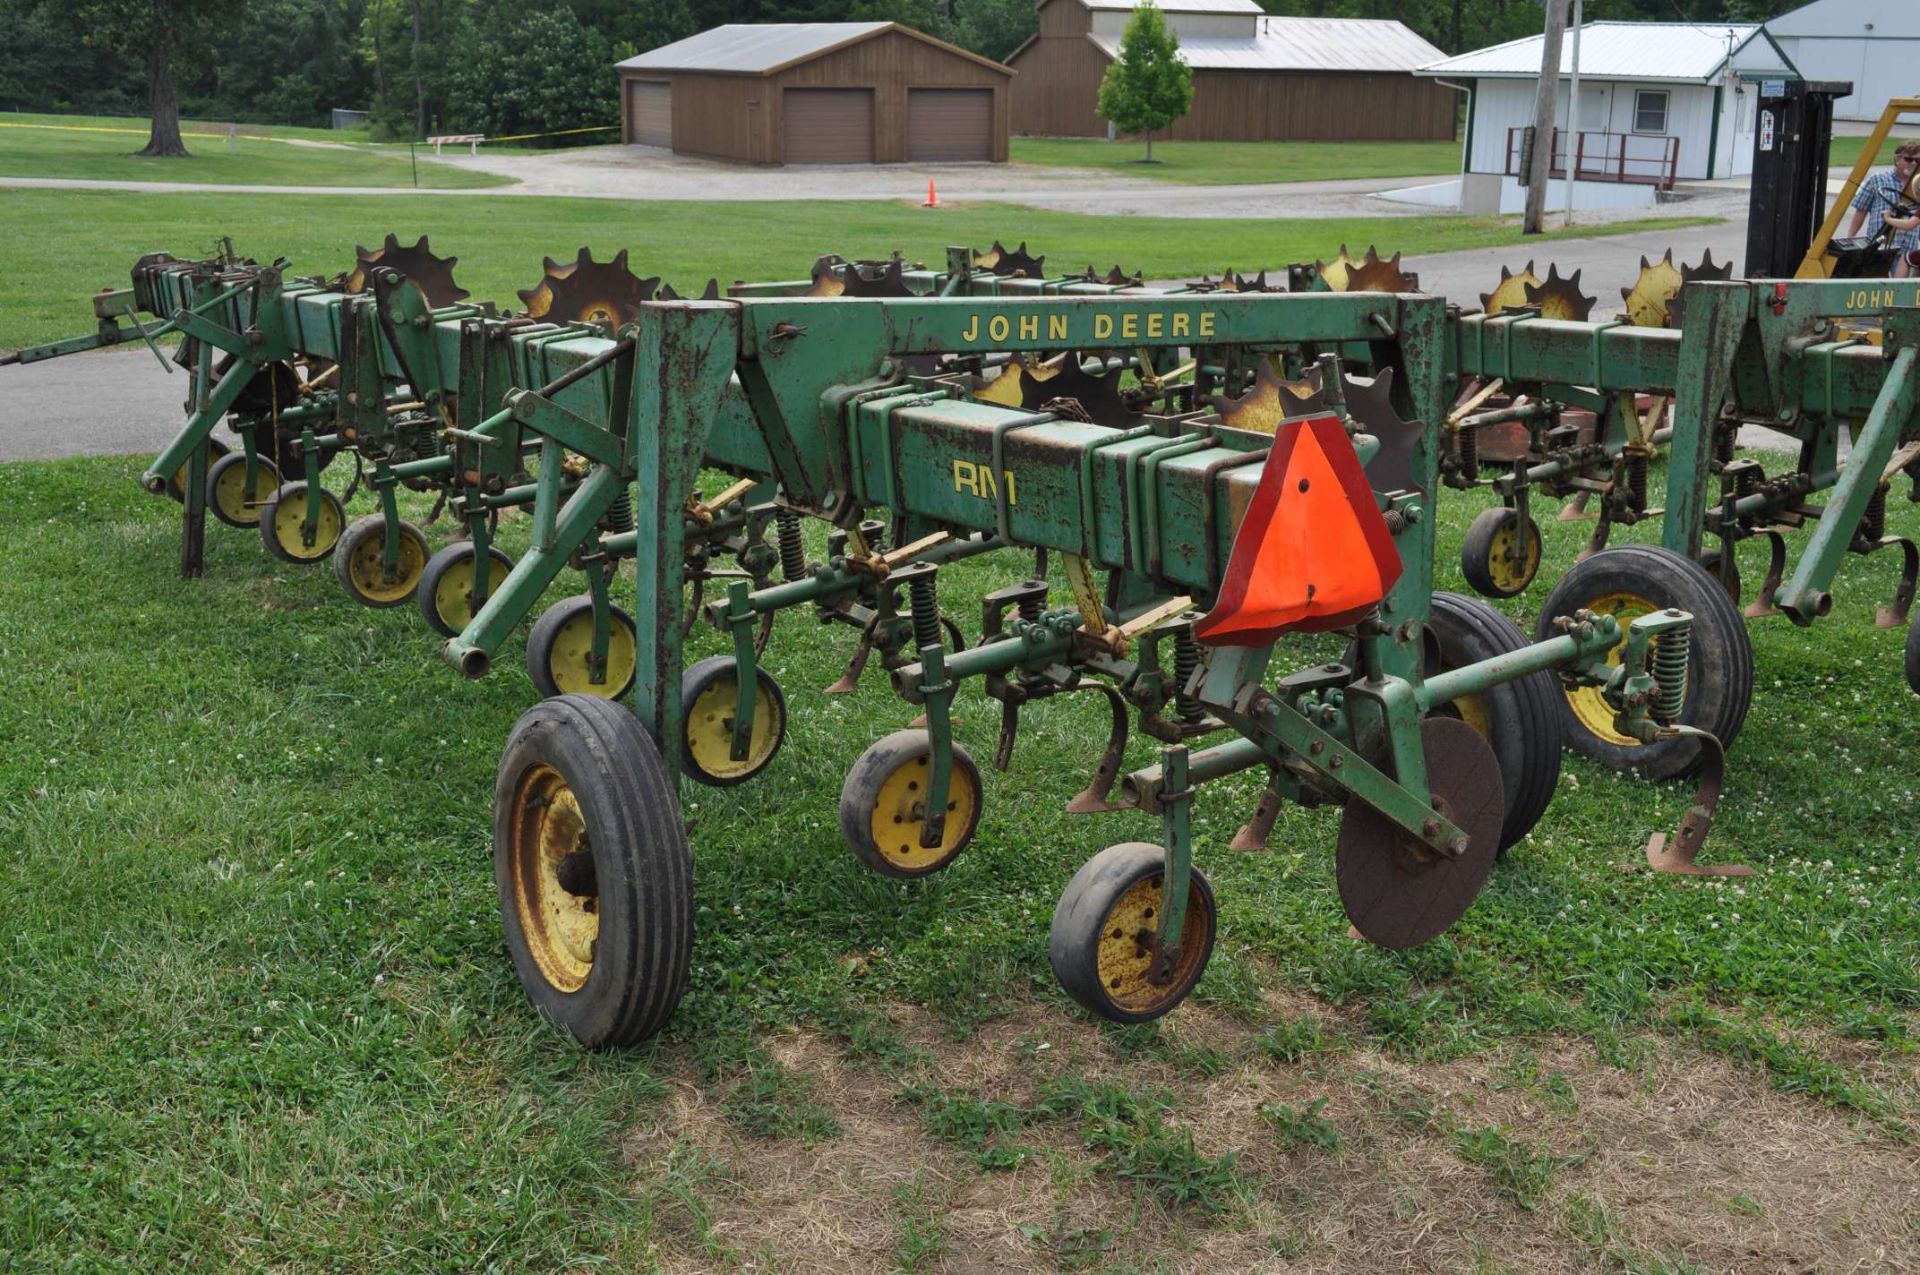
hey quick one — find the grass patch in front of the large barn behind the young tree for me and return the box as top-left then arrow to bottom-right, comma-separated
1010,136 -> 1459,186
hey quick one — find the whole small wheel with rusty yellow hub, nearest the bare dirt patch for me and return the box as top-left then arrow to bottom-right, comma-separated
1046,841 -> 1219,1023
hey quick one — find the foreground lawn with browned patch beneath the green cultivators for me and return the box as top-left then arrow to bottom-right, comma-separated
0,435 -> 1920,1271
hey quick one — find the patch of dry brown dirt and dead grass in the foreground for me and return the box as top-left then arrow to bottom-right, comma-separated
628,993 -> 1920,1275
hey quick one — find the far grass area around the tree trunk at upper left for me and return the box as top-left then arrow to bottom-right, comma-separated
0,115 -> 511,190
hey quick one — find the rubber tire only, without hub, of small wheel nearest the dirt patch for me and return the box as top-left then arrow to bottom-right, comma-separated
1046,841 -> 1219,1023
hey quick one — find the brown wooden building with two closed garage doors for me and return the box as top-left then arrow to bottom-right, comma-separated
618,23 -> 1014,163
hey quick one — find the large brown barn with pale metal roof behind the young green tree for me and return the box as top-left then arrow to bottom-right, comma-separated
1006,0 -> 1459,142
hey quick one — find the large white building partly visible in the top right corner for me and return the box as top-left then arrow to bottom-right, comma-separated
1766,0 -> 1920,119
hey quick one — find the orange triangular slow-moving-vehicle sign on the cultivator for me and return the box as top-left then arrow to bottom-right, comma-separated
1194,415 -> 1400,647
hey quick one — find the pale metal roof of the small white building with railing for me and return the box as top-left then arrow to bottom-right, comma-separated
1419,23 -> 1793,84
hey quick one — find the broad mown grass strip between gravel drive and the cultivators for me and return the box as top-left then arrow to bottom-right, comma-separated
0,190 -> 1701,348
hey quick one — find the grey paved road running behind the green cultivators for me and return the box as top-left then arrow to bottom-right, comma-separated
0,221 -> 1745,461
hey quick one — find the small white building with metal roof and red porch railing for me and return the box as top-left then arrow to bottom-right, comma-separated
1415,21 -> 1797,213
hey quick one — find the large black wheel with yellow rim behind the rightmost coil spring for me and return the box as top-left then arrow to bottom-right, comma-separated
1534,545 -> 1753,780
